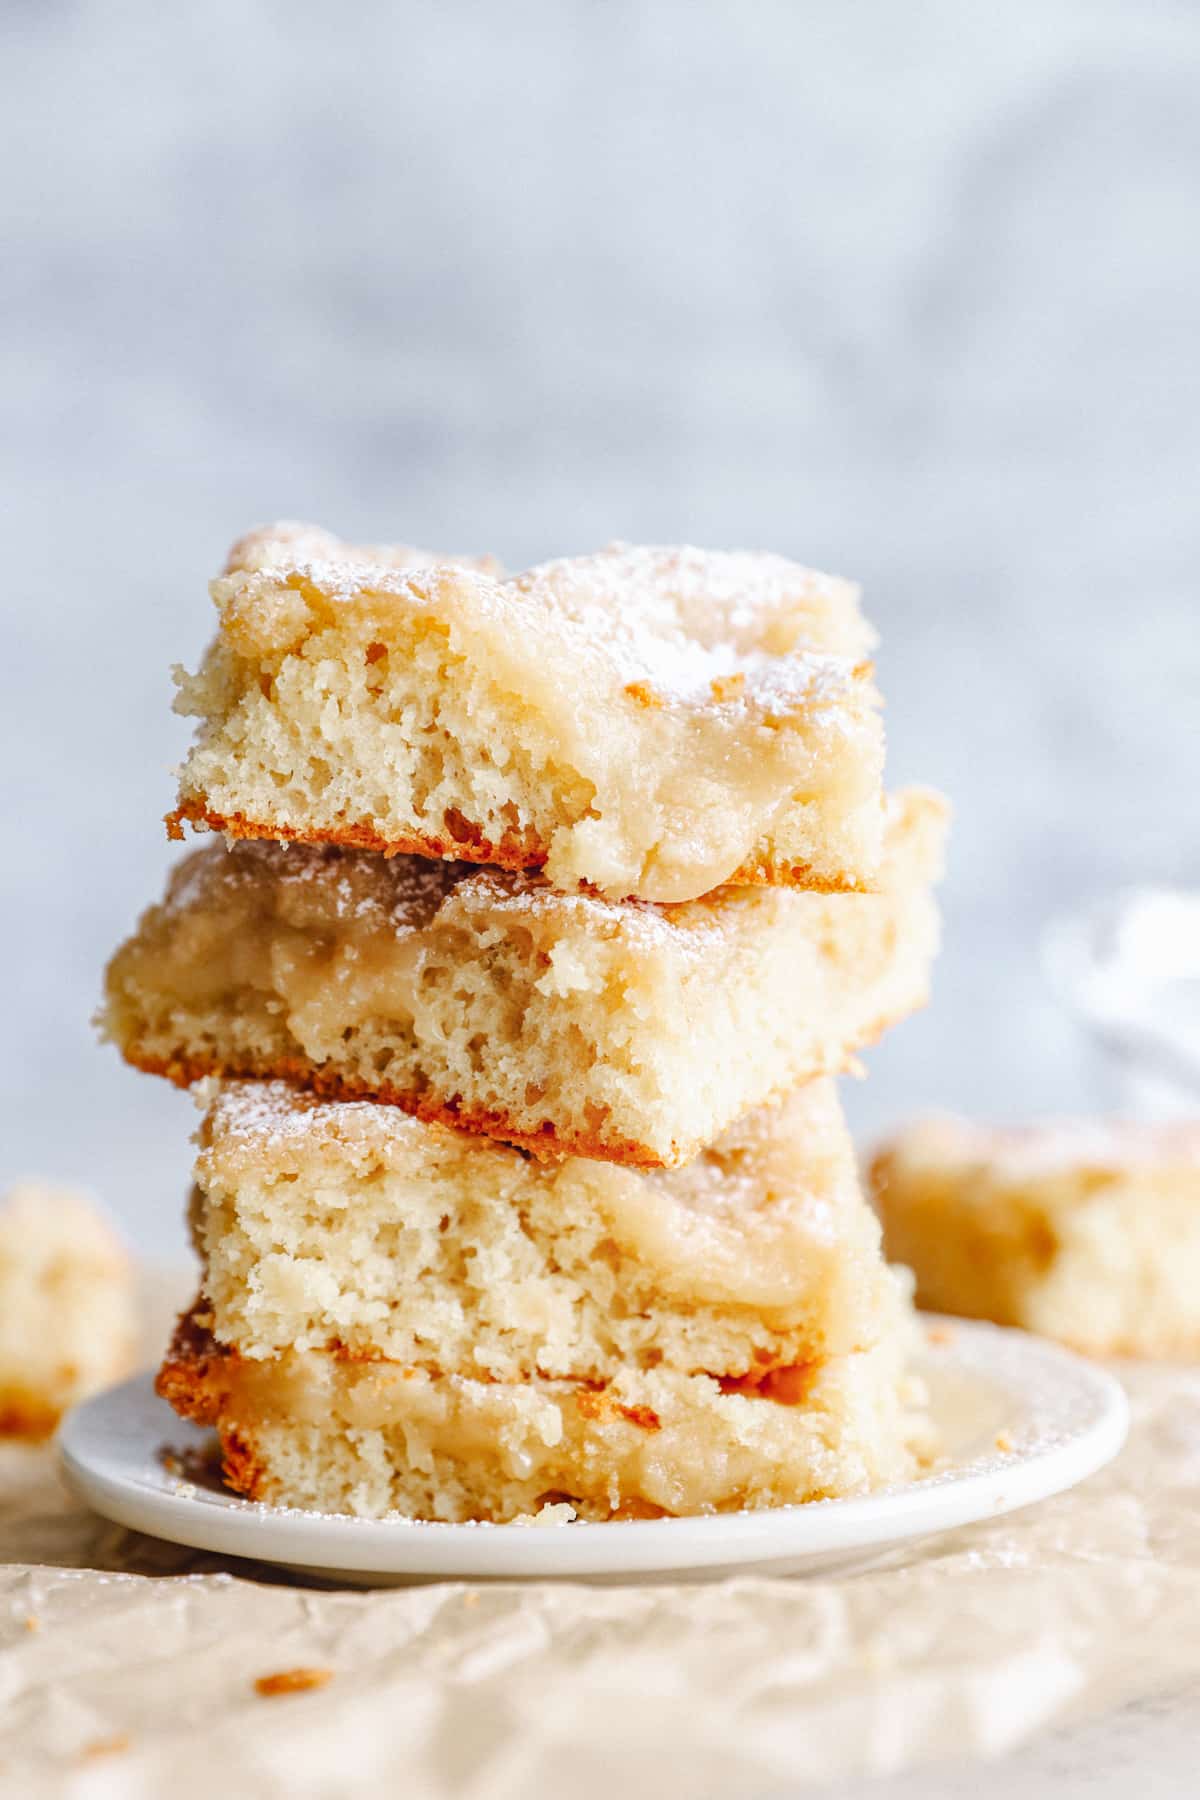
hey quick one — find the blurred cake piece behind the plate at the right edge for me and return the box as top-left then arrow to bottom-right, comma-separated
871,1118 -> 1200,1357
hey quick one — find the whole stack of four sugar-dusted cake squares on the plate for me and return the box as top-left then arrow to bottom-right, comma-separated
103,526 -> 945,1521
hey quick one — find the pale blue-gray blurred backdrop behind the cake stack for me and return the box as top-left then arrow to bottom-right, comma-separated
0,0 -> 1200,1251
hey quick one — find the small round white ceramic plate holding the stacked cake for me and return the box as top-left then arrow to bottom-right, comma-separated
59,1319 -> 1128,1582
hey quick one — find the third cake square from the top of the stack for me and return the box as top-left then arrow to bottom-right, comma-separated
193,1082 -> 887,1381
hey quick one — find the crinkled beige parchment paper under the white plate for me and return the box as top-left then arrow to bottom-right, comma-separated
0,1366 -> 1200,1800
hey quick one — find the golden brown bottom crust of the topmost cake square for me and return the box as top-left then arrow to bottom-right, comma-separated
164,799 -> 869,895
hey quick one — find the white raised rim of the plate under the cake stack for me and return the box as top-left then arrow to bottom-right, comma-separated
58,1314 -> 1130,1579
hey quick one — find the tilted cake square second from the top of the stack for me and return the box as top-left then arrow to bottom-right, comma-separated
101,790 -> 945,1166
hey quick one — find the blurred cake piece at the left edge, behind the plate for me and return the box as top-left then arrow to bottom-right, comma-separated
0,1181 -> 139,1438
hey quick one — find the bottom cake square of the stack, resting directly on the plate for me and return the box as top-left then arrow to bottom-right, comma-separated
158,1267 -> 934,1523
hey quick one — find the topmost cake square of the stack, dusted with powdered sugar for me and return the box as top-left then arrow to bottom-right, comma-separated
171,526 -> 883,902
